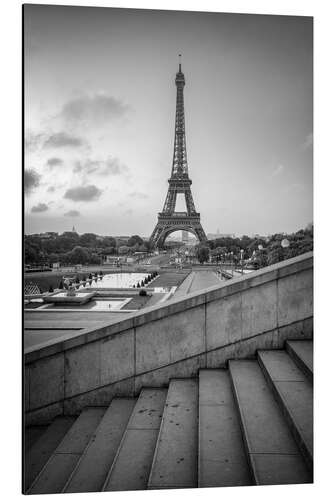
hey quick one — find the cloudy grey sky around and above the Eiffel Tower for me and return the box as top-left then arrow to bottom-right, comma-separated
24,5 -> 313,236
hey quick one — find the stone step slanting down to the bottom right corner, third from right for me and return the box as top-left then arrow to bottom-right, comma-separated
229,360 -> 311,485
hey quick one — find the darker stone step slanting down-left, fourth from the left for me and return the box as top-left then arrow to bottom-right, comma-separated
63,398 -> 136,493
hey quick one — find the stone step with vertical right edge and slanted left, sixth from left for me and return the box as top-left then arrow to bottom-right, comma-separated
148,379 -> 198,489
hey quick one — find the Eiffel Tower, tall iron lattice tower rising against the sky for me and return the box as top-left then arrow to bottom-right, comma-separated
150,55 -> 207,247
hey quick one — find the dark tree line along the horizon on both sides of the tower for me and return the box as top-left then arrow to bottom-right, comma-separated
24,225 -> 313,267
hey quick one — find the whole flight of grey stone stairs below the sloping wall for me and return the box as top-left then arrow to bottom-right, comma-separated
25,340 -> 313,494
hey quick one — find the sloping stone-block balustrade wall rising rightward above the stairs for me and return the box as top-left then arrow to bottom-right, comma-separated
25,253 -> 313,423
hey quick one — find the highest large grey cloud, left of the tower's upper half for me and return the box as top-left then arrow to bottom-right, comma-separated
60,93 -> 129,125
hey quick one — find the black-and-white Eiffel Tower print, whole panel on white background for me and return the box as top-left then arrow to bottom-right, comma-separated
22,4 -> 312,496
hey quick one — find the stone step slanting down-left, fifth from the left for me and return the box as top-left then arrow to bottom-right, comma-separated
103,389 -> 167,491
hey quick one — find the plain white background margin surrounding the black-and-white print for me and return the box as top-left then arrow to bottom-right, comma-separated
0,0 -> 333,500
